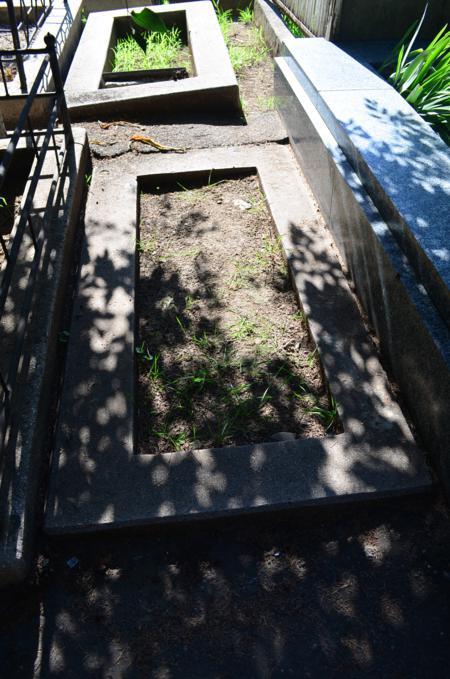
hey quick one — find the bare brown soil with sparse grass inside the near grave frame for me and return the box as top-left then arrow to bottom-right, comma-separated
137,176 -> 333,453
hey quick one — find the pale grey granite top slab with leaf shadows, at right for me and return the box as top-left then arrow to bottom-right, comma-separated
286,39 -> 450,327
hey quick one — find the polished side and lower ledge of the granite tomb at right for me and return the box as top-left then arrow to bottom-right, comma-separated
275,58 -> 450,489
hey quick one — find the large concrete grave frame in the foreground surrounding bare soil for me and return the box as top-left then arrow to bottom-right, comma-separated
45,145 -> 431,533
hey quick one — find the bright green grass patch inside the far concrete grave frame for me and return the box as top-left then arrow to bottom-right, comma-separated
113,27 -> 186,72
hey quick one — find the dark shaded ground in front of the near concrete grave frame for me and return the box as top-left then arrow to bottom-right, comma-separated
0,500 -> 450,679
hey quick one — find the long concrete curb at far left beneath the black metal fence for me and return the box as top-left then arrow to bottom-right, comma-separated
0,129 -> 87,583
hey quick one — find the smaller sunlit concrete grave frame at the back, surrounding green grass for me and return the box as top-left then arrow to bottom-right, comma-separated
65,0 -> 241,119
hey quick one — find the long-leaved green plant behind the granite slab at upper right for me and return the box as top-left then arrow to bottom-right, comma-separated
381,5 -> 450,143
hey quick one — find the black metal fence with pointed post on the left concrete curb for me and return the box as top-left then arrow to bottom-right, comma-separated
0,35 -> 73,453
